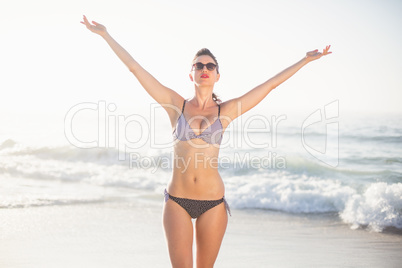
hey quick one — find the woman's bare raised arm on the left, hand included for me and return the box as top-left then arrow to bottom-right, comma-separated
81,16 -> 183,110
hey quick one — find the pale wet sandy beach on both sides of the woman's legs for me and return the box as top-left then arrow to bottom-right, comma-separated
0,197 -> 402,268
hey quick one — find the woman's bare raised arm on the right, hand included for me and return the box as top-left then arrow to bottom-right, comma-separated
222,46 -> 332,120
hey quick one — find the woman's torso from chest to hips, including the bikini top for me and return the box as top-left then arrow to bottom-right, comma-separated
167,101 -> 225,200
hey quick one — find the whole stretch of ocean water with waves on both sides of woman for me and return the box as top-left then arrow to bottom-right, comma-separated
0,109 -> 402,232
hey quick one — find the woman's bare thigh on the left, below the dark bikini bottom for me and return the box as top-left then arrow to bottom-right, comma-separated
163,200 -> 193,268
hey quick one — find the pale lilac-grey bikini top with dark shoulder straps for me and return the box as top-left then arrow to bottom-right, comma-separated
173,100 -> 223,144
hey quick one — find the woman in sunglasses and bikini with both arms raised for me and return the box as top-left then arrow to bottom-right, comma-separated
81,16 -> 331,267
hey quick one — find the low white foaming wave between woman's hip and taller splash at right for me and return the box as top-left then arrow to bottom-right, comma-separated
225,172 -> 356,213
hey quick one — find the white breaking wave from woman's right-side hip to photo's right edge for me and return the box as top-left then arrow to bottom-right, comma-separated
225,172 -> 402,232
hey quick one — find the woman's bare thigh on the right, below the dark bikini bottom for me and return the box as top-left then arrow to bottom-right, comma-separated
195,203 -> 228,268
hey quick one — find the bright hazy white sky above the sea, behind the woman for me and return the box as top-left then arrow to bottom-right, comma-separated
0,0 -> 402,144
